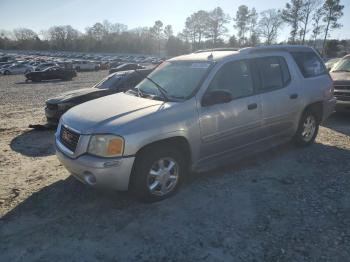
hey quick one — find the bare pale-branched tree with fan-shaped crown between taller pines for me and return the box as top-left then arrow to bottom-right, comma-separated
259,9 -> 283,45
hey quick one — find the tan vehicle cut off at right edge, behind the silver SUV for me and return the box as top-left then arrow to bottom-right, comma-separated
330,55 -> 350,113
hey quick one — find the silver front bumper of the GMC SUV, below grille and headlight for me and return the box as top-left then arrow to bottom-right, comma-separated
56,138 -> 135,191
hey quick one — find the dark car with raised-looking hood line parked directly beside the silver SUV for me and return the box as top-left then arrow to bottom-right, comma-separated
45,69 -> 152,125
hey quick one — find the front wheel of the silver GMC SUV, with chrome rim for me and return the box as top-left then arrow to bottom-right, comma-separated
130,146 -> 187,202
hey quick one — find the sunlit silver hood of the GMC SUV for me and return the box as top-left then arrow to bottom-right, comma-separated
62,93 -> 164,134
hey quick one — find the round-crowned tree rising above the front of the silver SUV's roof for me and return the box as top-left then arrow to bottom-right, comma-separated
206,7 -> 230,47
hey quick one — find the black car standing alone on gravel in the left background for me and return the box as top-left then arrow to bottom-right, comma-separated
25,66 -> 77,82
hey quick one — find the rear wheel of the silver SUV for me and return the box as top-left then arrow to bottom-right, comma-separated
294,109 -> 320,147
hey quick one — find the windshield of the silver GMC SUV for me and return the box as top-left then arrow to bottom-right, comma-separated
136,61 -> 211,100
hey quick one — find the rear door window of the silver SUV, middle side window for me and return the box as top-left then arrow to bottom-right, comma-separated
256,56 -> 291,91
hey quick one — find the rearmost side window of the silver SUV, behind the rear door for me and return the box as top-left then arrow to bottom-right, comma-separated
291,52 -> 327,78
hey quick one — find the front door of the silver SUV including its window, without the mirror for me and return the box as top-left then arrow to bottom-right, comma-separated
199,60 -> 262,160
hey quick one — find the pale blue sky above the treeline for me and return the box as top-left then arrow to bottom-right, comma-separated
0,0 -> 350,41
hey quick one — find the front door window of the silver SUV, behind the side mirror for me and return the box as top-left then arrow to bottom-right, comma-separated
209,61 -> 254,98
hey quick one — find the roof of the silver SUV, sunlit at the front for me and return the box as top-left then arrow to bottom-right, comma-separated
168,45 -> 314,61
